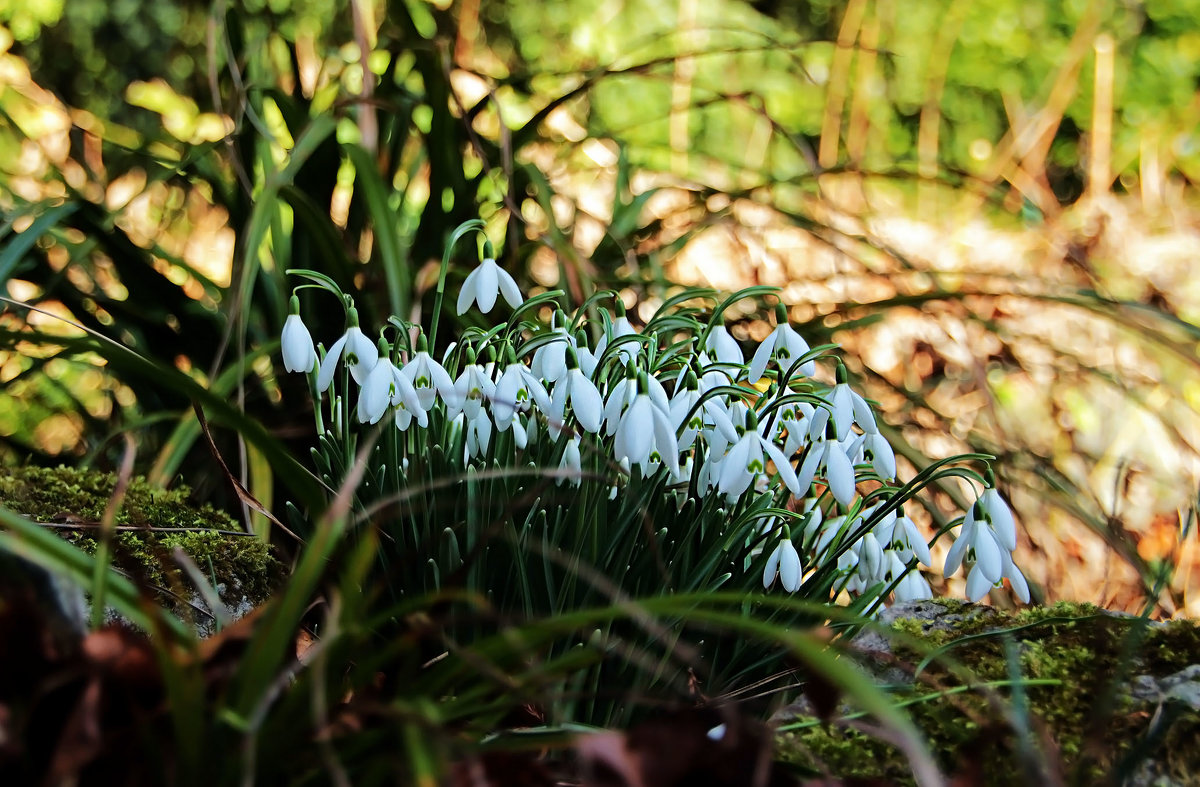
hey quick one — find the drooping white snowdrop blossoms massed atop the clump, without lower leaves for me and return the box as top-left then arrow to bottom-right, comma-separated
282,259 -> 1030,601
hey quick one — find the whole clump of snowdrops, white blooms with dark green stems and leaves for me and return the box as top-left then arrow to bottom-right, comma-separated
282,227 -> 1030,628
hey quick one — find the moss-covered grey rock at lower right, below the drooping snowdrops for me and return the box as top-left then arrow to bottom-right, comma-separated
780,601 -> 1200,785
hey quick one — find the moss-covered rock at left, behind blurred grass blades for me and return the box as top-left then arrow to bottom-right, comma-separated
0,467 -> 283,631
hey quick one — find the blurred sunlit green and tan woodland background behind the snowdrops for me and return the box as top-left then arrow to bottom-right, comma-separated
0,0 -> 1200,617
